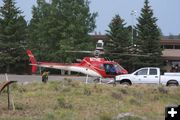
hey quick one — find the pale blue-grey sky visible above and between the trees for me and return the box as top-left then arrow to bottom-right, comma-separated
0,0 -> 180,35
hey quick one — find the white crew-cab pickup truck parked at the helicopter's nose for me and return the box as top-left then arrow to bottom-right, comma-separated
115,67 -> 180,86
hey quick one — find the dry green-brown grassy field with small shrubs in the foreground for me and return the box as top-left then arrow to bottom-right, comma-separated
0,80 -> 180,120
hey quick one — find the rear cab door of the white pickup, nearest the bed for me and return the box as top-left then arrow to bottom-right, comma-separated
147,68 -> 160,84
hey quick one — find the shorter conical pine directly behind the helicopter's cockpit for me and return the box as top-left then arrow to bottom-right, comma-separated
105,15 -> 132,70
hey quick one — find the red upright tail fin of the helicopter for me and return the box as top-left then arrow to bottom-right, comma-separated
26,49 -> 37,73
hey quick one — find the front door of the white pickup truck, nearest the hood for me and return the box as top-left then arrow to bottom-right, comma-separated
133,68 -> 148,83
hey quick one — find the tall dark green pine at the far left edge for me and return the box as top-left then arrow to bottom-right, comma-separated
0,0 -> 26,72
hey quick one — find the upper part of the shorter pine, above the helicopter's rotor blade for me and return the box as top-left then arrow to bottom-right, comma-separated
106,15 -> 130,53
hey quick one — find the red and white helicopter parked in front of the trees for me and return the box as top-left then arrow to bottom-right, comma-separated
26,40 -> 128,78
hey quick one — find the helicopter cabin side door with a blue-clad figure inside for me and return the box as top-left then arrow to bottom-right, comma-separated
104,64 -> 117,75
